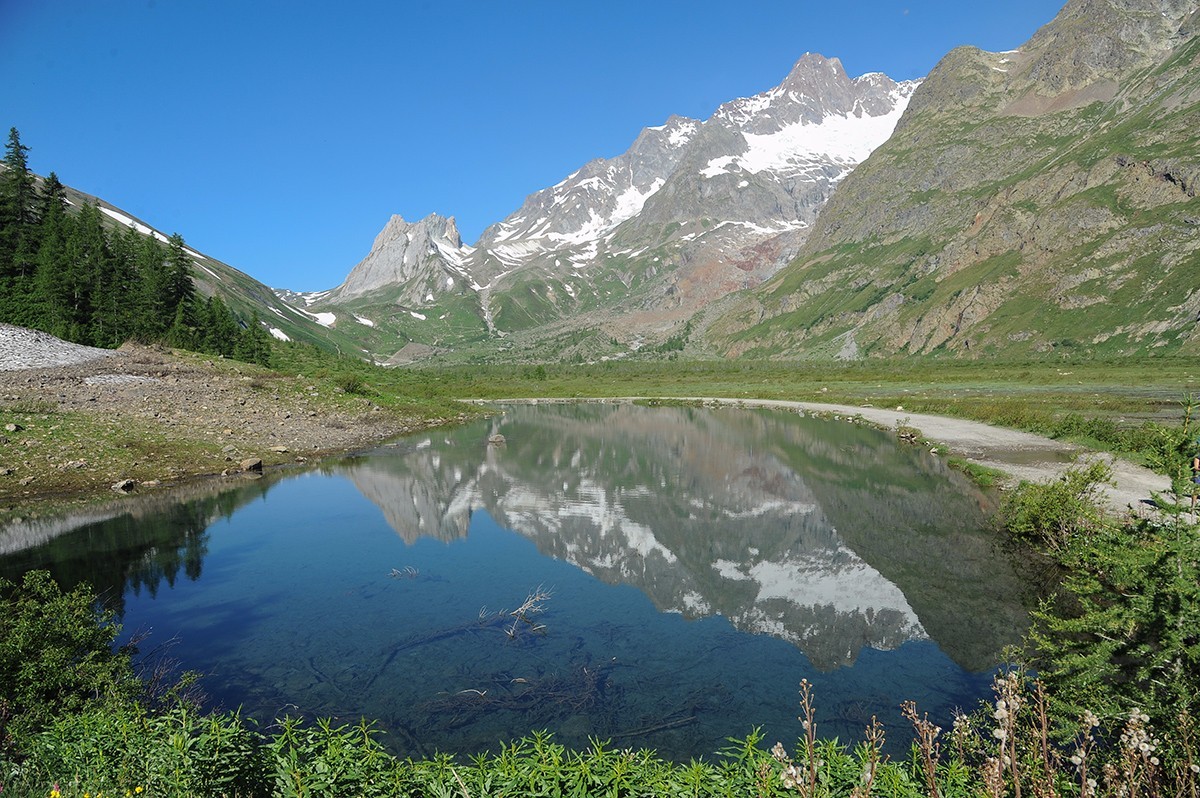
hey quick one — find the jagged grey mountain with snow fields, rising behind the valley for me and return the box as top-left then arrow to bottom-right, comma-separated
300,53 -> 918,348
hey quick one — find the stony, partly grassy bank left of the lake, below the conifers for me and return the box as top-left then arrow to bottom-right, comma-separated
0,325 -> 463,508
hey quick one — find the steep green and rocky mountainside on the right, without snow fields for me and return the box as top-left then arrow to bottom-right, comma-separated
709,0 -> 1200,359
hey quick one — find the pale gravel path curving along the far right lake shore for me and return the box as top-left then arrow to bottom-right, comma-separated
477,397 -> 1170,514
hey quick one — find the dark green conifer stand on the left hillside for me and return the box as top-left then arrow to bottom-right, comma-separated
0,128 -> 271,366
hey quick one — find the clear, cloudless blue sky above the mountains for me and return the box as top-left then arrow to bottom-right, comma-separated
0,0 -> 1062,290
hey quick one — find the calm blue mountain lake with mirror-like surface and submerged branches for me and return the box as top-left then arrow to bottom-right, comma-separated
0,404 -> 1028,760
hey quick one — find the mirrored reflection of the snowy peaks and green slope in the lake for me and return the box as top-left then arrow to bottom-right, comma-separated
346,404 -> 1025,670
